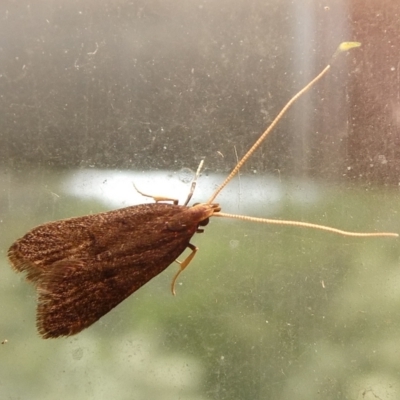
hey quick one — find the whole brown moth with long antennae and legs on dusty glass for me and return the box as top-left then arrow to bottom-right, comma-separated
8,42 -> 398,338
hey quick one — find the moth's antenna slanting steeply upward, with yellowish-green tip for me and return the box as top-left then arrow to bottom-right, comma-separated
207,42 -> 361,204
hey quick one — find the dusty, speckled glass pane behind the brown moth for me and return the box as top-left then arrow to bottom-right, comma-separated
0,0 -> 400,400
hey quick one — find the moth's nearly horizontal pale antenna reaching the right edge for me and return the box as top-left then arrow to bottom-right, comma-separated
213,212 -> 399,237
